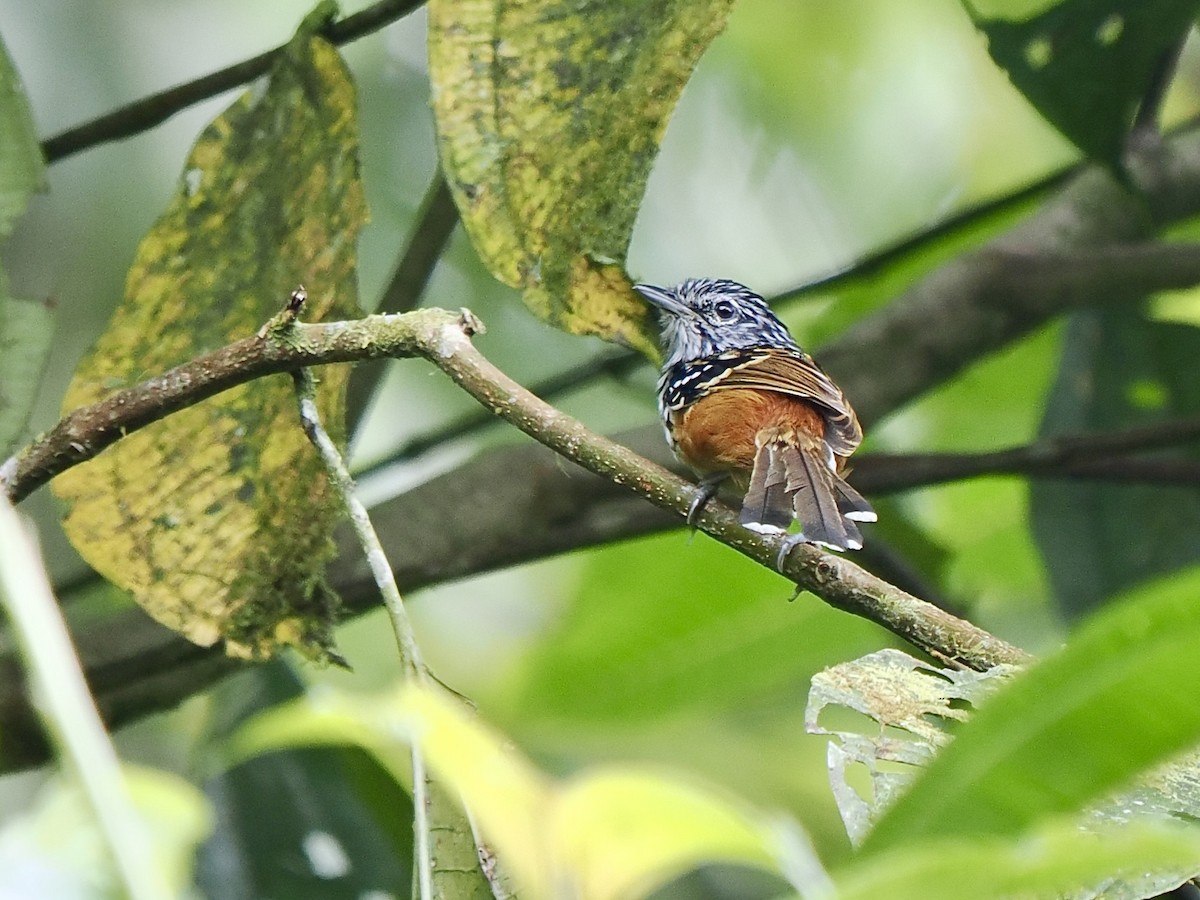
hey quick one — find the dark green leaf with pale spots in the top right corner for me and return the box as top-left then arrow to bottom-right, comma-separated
962,0 -> 1200,167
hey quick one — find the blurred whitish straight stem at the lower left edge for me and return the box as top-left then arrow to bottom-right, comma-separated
0,498 -> 173,900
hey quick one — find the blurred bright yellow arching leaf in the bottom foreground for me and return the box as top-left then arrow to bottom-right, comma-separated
232,686 -> 794,900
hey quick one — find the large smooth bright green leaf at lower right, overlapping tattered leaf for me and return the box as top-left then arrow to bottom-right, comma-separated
863,570 -> 1200,853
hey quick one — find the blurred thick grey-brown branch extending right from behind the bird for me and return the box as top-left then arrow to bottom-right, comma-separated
816,127 -> 1200,424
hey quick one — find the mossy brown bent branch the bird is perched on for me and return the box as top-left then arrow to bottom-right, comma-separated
0,310 -> 1027,670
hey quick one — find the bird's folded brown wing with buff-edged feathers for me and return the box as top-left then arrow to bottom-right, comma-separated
703,347 -> 863,456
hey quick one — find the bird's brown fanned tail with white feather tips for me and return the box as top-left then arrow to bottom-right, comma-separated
742,434 -> 876,550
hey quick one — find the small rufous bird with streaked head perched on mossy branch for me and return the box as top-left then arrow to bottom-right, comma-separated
634,278 -> 877,570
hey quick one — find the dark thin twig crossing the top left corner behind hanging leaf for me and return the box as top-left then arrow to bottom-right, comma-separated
42,0 -> 424,163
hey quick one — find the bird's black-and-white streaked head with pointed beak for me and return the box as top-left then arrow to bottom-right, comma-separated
634,278 -> 799,367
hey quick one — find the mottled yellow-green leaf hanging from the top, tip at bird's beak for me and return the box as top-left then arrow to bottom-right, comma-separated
427,0 -> 732,355
